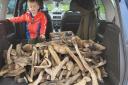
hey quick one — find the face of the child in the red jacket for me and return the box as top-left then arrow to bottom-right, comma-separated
28,2 -> 39,16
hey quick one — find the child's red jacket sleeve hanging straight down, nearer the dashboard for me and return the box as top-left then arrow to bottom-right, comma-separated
40,15 -> 47,35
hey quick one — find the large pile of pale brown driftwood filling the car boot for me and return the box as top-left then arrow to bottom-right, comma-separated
0,32 -> 107,85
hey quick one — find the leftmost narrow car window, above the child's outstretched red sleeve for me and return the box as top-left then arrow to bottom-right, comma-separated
6,0 -> 17,18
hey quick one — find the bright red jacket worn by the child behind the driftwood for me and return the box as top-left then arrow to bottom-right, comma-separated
9,12 -> 47,39
